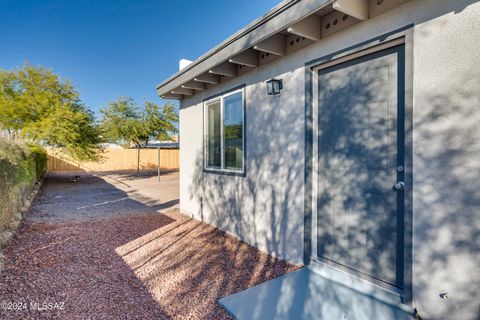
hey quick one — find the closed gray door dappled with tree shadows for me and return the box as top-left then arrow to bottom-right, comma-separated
317,46 -> 404,287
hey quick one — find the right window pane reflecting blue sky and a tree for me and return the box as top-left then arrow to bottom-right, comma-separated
223,92 -> 243,170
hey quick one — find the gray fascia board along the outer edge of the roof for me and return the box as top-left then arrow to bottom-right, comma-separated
157,0 -> 333,95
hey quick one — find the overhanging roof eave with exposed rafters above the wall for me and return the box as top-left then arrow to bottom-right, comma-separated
156,0 -> 408,99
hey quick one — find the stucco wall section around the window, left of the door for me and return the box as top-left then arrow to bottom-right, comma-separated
180,53 -> 305,263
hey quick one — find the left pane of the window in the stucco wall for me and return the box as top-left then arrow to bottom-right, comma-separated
207,101 -> 222,168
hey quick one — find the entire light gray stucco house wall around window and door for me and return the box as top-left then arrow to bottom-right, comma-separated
180,0 -> 480,319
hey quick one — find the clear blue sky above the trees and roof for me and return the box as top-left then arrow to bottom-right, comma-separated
0,0 -> 279,116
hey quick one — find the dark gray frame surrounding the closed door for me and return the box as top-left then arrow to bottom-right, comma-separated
304,26 -> 413,304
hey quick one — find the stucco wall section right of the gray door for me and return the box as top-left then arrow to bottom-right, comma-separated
413,1 -> 480,319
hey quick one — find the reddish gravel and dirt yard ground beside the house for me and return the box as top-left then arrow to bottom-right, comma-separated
0,173 -> 298,319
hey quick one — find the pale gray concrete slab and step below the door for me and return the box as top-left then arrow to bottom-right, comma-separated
219,264 -> 413,320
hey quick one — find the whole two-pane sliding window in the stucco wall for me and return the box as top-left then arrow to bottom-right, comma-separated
204,89 -> 245,173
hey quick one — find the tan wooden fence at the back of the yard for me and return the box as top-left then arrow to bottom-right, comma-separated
47,148 -> 180,172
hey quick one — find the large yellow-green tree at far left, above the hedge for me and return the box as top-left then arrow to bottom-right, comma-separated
0,63 -> 101,160
